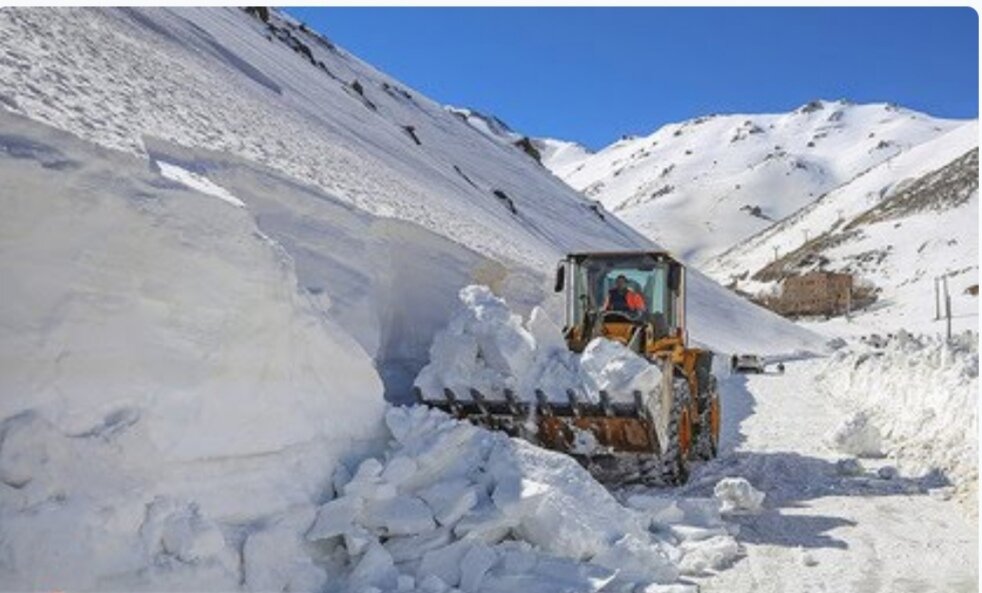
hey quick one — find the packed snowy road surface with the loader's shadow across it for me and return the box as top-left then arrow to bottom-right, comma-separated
685,360 -> 978,593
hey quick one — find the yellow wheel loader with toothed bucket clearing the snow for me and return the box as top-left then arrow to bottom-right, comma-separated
416,251 -> 720,484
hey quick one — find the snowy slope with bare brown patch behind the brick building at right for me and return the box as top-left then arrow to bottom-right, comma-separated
705,122 -> 979,333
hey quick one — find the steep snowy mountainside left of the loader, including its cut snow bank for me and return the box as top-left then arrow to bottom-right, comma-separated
0,8 -> 822,590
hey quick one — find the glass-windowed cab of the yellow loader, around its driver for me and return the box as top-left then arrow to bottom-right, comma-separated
556,252 -> 685,354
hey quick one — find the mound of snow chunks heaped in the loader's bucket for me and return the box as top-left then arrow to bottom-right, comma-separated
415,285 -> 661,402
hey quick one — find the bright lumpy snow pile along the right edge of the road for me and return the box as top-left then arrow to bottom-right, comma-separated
820,332 -> 978,486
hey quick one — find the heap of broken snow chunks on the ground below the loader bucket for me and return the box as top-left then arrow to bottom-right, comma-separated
316,406 -> 736,592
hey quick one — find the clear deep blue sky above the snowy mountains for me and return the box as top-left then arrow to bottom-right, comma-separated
288,8 -> 979,148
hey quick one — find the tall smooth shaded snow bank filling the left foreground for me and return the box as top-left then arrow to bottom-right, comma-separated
0,114 -> 384,590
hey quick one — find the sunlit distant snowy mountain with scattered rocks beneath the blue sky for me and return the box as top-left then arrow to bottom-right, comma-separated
539,100 -> 964,265
